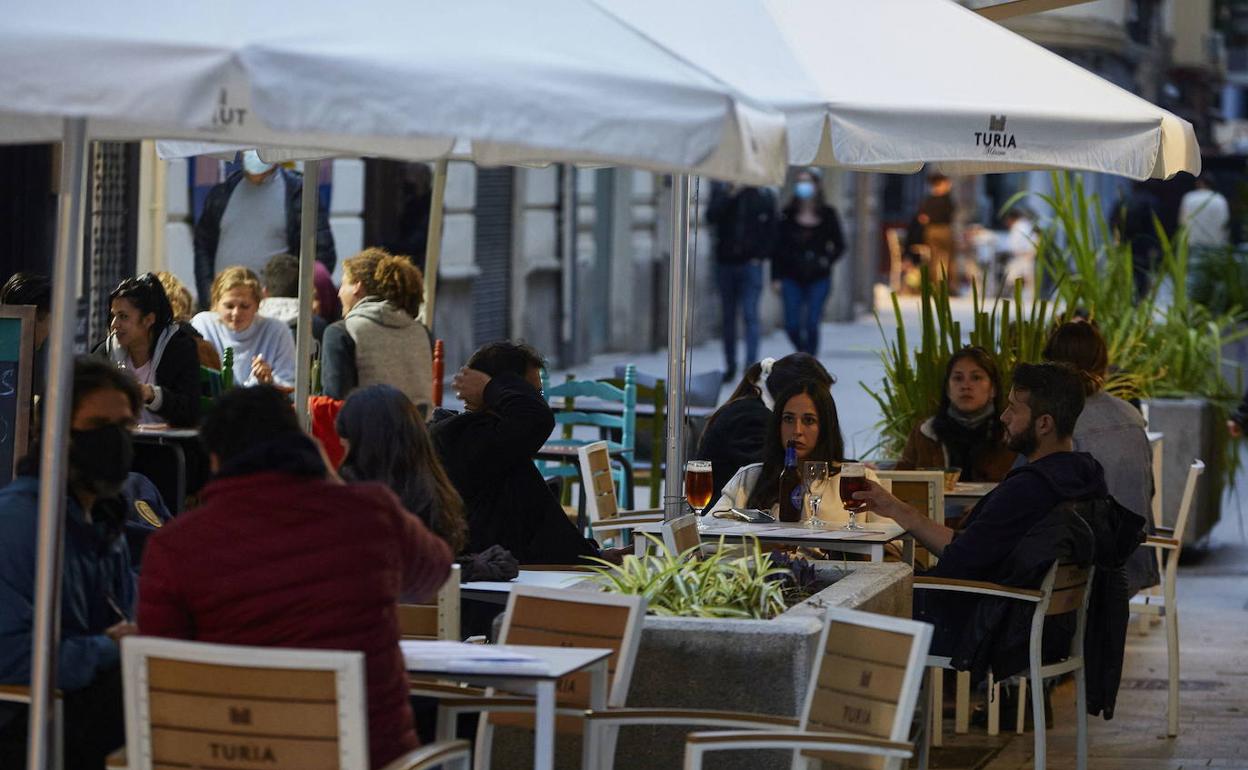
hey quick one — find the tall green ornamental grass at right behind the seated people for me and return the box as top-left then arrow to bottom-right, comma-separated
861,173 -> 1248,489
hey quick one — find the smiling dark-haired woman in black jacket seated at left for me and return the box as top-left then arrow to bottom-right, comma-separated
95,273 -> 200,427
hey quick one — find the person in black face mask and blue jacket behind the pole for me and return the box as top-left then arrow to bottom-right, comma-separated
0,356 -> 142,770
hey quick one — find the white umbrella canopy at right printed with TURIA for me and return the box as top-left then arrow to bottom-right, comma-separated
595,0 -> 1201,180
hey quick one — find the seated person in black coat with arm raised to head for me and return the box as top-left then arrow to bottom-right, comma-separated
429,342 -> 598,564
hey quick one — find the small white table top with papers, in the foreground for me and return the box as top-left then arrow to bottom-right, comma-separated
399,640 -> 612,679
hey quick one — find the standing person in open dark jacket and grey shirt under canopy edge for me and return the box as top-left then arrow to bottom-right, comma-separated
195,150 -> 338,309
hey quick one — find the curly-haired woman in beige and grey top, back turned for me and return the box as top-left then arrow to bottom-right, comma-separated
321,248 -> 433,414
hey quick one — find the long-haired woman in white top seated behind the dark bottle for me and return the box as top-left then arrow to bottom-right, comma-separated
710,379 -> 845,514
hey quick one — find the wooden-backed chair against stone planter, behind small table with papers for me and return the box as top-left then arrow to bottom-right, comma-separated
438,585 -> 645,770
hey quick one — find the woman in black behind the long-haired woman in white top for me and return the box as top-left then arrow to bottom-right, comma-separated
696,353 -> 836,500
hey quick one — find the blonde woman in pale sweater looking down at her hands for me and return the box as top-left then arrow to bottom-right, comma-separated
191,267 -> 295,388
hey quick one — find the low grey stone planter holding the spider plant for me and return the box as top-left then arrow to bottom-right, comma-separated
493,562 -> 914,770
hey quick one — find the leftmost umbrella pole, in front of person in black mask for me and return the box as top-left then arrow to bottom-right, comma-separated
26,117 -> 89,770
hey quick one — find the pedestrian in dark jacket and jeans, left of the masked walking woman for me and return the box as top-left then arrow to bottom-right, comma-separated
706,182 -> 776,382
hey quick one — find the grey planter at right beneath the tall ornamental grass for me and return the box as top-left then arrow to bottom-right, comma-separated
1146,398 -> 1226,545
